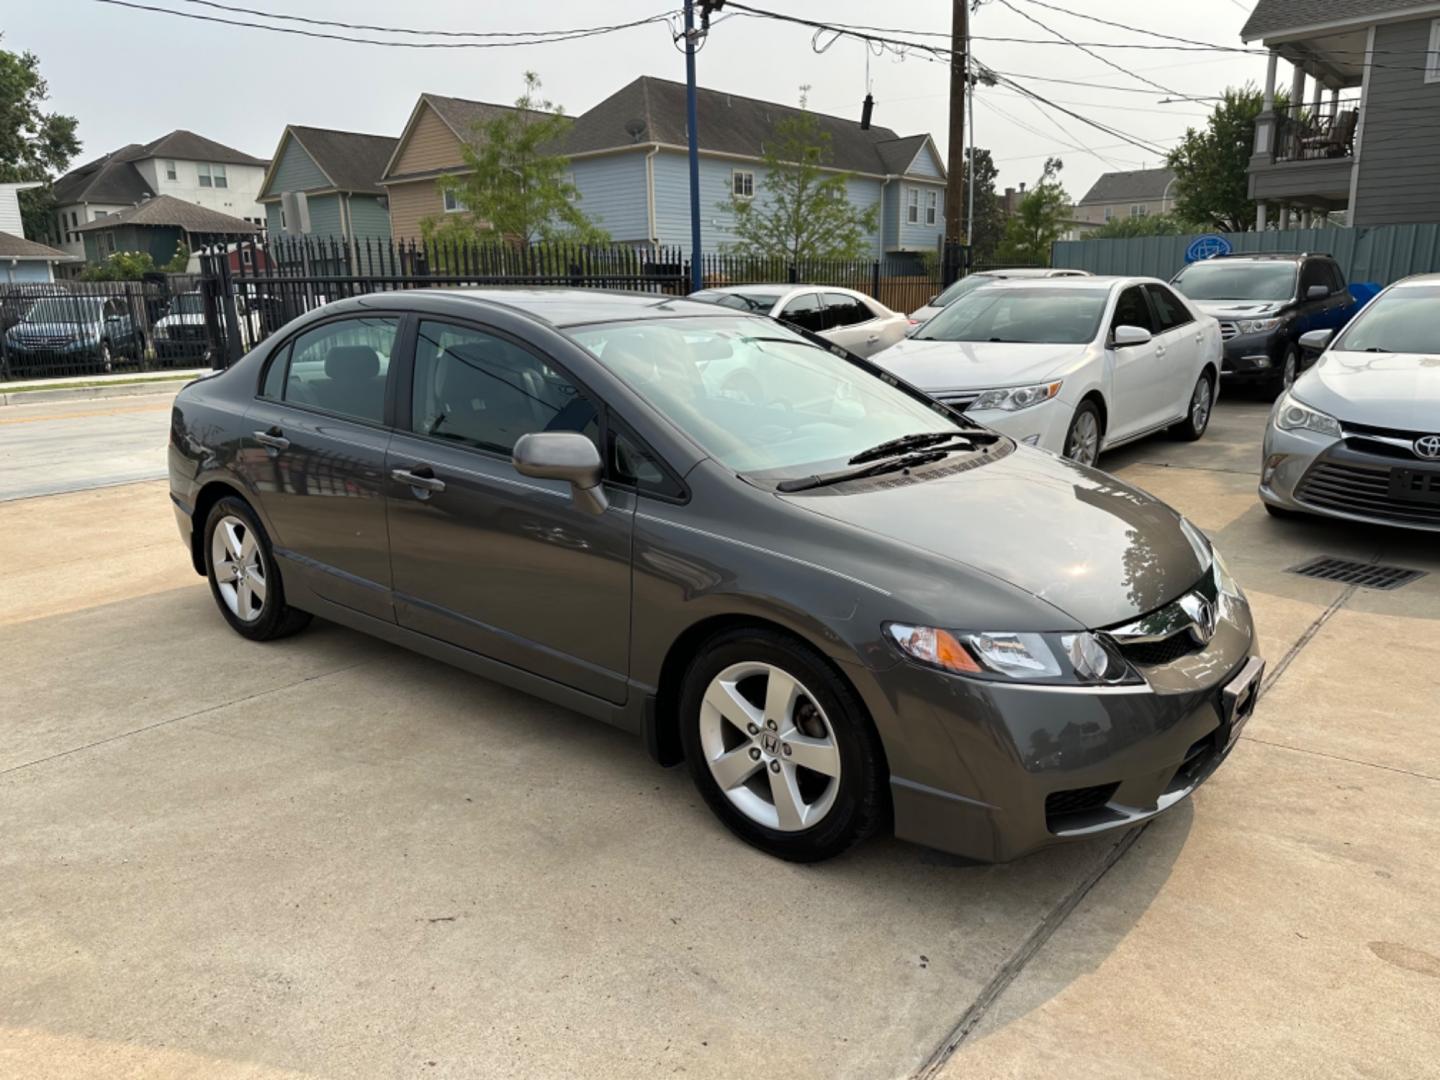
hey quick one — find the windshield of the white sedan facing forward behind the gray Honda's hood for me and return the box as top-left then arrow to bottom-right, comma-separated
916,285 -> 1110,346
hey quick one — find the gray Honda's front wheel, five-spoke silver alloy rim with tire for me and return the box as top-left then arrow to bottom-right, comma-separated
681,629 -> 886,863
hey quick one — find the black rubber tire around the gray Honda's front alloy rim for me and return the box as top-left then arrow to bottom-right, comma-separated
680,628 -> 890,863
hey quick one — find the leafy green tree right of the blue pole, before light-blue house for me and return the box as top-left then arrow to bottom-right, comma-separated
719,111 -> 878,262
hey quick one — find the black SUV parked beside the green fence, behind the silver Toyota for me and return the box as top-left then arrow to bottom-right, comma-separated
1171,253 -> 1359,395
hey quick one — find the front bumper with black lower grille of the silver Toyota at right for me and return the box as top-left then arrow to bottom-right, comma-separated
1260,416 -> 1440,531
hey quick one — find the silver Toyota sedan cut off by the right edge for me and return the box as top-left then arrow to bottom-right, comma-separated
1260,274 -> 1440,531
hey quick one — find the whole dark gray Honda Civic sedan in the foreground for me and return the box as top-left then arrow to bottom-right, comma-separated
170,289 -> 1263,861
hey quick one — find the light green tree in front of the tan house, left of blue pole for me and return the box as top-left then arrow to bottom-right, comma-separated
420,72 -> 609,245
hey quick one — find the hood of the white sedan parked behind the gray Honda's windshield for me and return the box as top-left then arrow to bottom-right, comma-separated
871,337 -> 1086,390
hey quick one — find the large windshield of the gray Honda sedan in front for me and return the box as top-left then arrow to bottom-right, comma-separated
569,315 -> 968,481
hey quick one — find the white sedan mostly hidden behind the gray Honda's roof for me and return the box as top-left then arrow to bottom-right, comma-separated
690,285 -> 910,356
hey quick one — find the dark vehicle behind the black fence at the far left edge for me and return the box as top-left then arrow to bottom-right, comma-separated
4,292 -> 145,374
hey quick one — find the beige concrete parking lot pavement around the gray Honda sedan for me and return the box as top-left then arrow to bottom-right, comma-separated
0,399 -> 1440,1077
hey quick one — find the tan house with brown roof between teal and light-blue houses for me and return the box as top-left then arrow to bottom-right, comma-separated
380,94 -> 529,240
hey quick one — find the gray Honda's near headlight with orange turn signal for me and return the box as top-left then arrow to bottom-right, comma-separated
884,622 -> 1143,685
